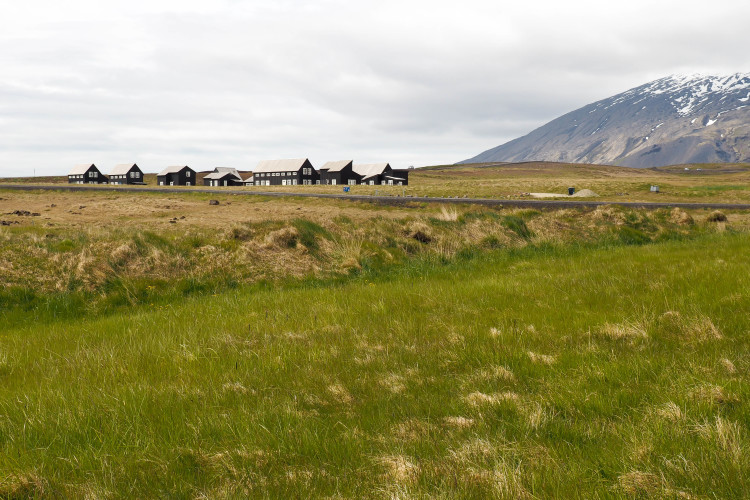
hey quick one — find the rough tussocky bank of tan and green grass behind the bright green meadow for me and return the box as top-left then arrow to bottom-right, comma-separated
0,196 -> 724,324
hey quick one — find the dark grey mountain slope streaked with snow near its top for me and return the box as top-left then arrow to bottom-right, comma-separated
461,73 -> 750,167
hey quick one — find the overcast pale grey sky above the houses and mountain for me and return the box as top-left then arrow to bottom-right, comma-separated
0,0 -> 750,176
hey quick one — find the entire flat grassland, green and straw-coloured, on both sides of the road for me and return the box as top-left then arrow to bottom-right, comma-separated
0,166 -> 750,498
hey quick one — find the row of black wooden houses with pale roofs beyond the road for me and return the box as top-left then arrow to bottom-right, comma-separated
68,158 -> 409,186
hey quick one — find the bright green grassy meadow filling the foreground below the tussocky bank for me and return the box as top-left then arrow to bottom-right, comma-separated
0,232 -> 750,498
